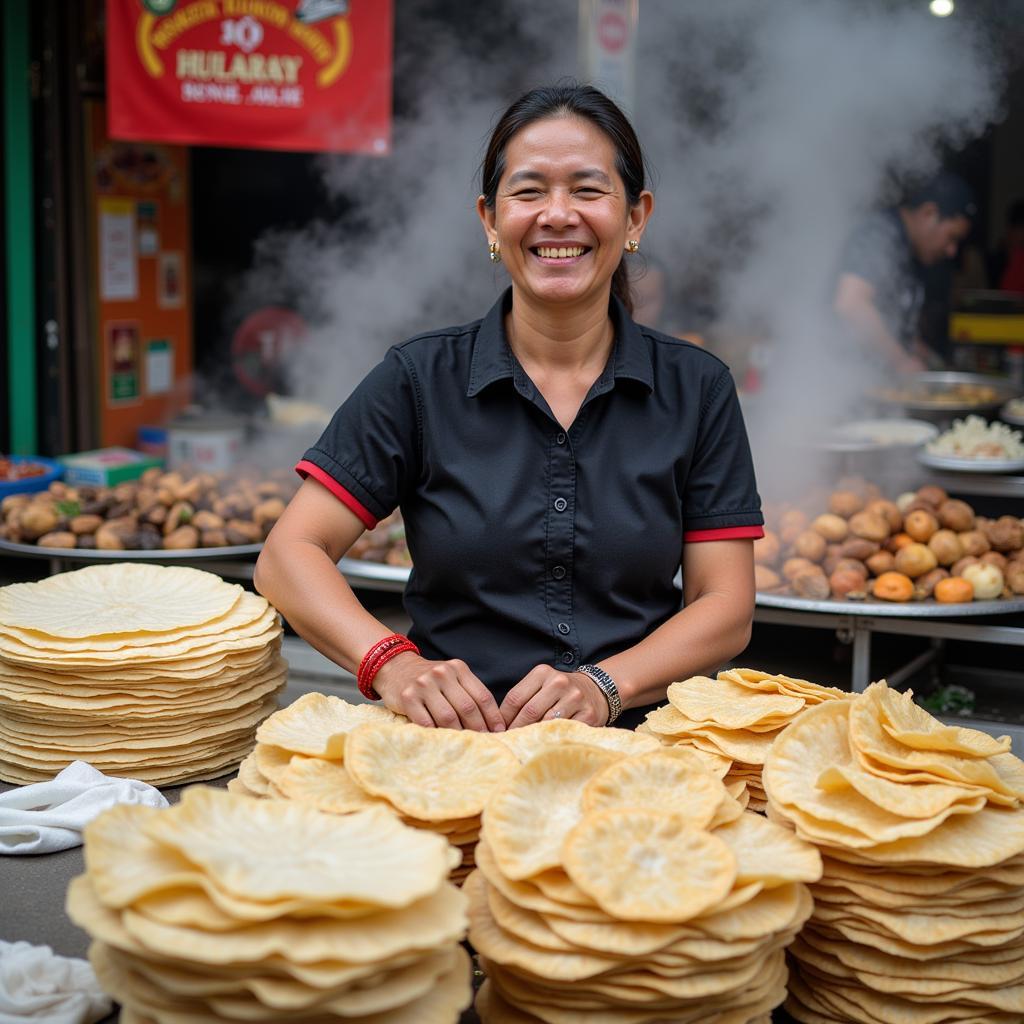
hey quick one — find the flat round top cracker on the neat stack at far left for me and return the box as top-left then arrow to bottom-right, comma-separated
0,562 -> 244,639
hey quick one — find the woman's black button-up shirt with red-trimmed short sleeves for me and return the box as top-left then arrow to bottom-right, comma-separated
296,291 -> 763,699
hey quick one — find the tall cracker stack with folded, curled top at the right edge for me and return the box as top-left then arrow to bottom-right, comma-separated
764,683 -> 1024,1024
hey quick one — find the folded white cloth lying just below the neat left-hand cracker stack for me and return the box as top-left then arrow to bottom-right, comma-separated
0,761 -> 167,854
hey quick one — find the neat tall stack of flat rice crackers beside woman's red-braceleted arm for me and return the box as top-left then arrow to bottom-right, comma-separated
0,563 -> 288,785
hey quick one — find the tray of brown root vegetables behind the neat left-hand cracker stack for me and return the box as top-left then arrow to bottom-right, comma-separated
0,469 -> 298,561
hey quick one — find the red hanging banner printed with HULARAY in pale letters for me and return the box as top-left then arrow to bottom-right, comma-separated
106,0 -> 392,154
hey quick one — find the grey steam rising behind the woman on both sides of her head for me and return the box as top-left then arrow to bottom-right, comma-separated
232,0 -> 1000,493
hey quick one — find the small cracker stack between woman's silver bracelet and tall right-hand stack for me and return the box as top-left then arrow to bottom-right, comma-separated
637,669 -> 849,811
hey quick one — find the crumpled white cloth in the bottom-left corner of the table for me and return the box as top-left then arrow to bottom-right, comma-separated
0,941 -> 112,1024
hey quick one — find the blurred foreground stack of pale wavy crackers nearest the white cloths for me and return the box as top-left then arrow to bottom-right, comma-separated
68,787 -> 471,1024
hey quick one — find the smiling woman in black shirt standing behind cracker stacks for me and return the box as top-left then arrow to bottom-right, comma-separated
255,85 -> 763,730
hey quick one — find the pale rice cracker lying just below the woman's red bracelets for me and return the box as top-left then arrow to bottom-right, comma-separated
256,693 -> 408,760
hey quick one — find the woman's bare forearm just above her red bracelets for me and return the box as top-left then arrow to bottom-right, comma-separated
253,541 -> 391,674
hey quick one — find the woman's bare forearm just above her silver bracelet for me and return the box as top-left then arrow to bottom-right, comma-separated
600,592 -> 754,708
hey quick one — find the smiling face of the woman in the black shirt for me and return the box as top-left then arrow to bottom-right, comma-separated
477,117 -> 653,304
